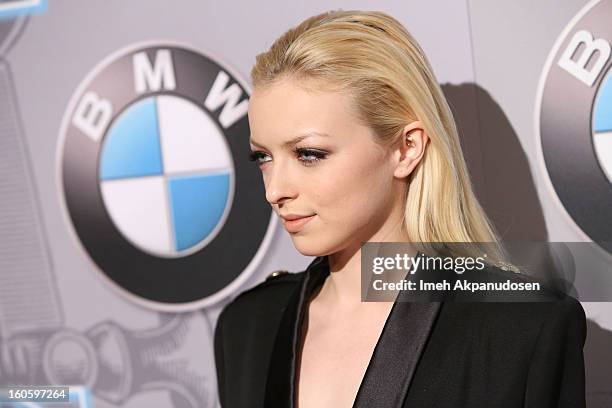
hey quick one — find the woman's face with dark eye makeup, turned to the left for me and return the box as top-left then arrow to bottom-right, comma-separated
249,79 -> 406,256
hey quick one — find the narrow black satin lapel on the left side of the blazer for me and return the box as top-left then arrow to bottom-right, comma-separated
264,257 -> 329,408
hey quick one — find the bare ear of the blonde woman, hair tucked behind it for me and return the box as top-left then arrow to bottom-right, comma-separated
393,120 -> 429,178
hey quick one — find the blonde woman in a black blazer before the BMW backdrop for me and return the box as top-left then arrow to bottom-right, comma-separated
215,11 -> 586,408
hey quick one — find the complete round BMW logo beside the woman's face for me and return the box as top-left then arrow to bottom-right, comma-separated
58,41 -> 276,311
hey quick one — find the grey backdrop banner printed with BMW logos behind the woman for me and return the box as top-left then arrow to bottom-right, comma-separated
0,0 -> 612,408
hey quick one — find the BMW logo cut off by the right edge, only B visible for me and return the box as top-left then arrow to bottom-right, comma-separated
535,0 -> 612,254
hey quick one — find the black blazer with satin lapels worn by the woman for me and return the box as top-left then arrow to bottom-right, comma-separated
214,256 -> 586,408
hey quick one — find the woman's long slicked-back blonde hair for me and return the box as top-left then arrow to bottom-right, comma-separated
251,10 -> 506,263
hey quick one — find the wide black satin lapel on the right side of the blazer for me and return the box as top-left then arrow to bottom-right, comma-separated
353,300 -> 440,408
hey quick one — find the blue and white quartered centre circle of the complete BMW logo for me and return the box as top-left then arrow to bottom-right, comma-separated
99,95 -> 233,257
